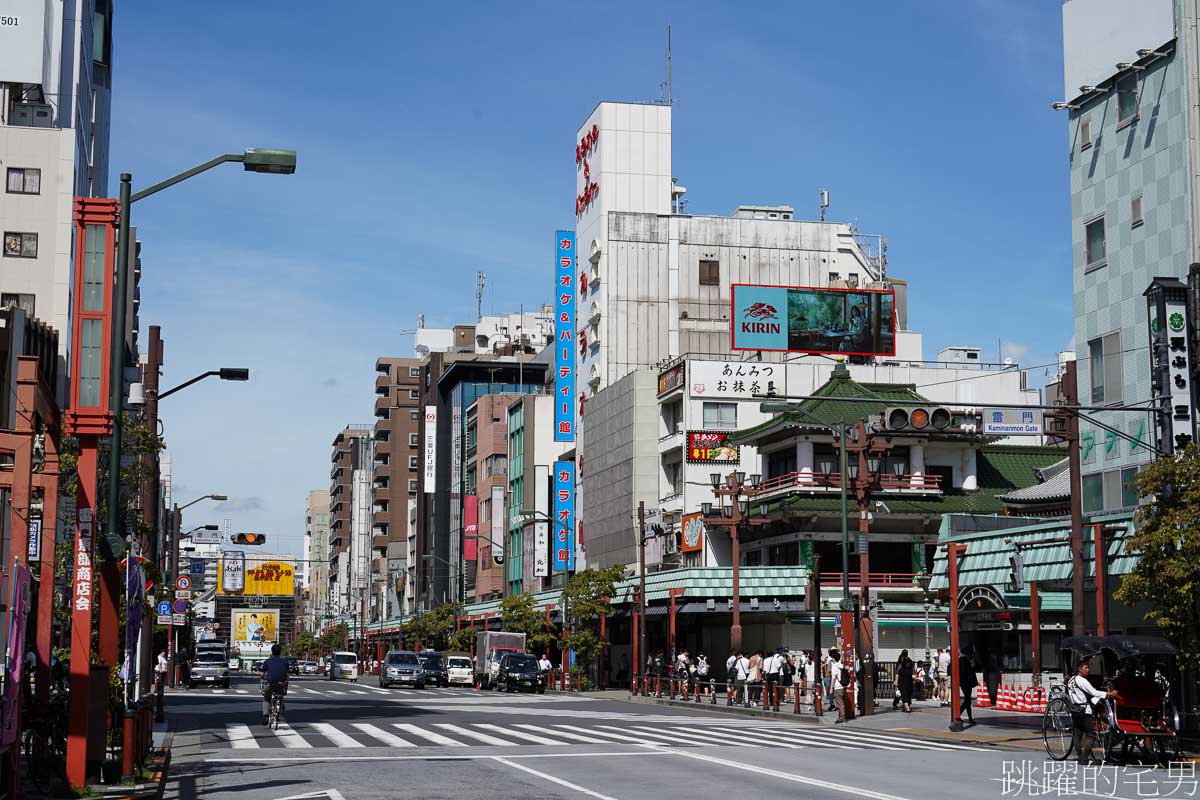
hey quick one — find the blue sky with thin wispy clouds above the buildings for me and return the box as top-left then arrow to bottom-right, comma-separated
110,0 -> 1073,549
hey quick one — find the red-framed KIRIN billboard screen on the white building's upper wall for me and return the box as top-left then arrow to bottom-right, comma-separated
730,283 -> 896,355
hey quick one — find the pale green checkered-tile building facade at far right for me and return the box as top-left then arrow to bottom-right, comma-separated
1055,0 -> 1200,513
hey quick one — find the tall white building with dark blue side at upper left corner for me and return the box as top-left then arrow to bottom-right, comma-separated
0,0 -> 113,401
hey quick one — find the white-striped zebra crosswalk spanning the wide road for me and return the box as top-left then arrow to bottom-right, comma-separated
218,717 -> 990,751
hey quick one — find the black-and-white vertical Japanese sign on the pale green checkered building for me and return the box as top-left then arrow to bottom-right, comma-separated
1142,278 -> 1195,453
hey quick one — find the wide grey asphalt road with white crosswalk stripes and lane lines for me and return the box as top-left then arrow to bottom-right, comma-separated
164,676 -> 1198,800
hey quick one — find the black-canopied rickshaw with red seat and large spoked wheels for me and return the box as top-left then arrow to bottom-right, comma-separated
1042,636 -> 1180,765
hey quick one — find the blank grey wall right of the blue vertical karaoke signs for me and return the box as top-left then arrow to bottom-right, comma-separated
582,369 -> 659,567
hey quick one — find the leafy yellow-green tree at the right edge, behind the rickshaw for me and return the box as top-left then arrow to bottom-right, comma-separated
1114,444 -> 1200,667
